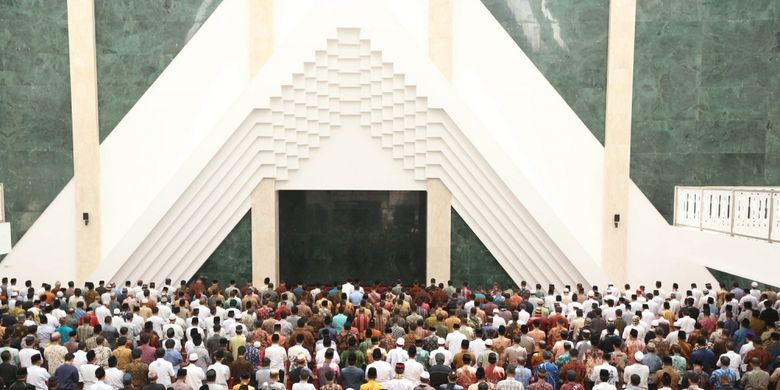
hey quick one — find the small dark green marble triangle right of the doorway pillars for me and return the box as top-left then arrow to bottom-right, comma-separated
450,209 -> 512,286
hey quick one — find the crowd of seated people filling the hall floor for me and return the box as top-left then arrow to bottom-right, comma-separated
0,277 -> 780,390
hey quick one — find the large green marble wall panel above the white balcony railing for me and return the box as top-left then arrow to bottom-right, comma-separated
631,0 -> 780,222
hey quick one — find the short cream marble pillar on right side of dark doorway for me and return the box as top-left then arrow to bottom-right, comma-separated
425,179 -> 452,283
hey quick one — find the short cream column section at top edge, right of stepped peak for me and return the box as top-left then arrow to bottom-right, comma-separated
428,0 -> 454,81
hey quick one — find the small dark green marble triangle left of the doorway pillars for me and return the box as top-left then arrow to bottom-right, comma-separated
195,212 -> 252,286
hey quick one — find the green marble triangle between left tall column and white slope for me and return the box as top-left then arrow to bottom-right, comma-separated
95,0 -> 221,141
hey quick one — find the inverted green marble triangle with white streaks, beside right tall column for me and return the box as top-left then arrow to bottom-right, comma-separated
482,0 -> 612,143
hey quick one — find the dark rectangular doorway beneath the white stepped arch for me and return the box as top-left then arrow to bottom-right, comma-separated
279,191 -> 426,284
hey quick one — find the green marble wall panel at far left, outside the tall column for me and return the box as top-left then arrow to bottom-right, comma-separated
0,0 -> 73,253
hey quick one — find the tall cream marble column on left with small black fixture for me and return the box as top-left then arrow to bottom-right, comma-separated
68,0 -> 102,283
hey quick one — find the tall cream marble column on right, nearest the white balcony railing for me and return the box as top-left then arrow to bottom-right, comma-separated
602,0 -> 636,285
